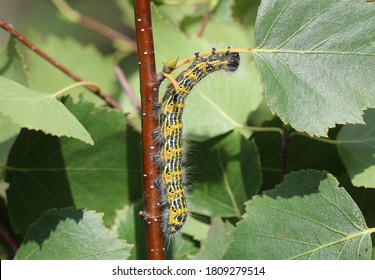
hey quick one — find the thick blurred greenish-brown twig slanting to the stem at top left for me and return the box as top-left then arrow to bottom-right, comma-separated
52,0 -> 137,52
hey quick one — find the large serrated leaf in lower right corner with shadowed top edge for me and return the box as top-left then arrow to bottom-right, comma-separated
224,171 -> 375,259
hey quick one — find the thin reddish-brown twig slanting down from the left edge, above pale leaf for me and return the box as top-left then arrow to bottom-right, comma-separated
0,19 -> 121,110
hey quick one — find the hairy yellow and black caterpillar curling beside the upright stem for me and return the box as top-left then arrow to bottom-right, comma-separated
154,48 -> 240,235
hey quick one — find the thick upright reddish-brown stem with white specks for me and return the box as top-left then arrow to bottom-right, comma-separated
134,0 -> 164,260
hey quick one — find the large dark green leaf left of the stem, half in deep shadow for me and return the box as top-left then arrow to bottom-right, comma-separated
6,99 -> 132,233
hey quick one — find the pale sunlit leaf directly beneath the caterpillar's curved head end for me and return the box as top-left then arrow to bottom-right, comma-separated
184,49 -> 262,141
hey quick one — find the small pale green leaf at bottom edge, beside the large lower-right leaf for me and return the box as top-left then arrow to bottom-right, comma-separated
192,218 -> 233,260
